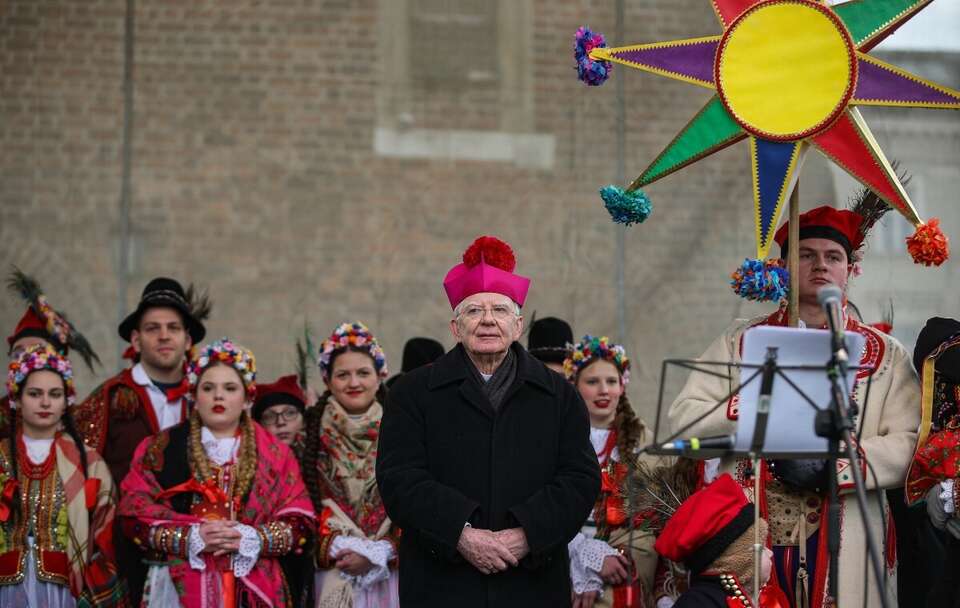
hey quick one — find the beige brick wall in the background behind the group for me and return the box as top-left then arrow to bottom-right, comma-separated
0,0 -> 960,428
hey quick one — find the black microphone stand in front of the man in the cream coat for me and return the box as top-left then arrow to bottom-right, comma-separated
816,342 -> 890,608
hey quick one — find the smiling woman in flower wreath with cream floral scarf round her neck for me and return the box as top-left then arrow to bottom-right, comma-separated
302,322 -> 399,608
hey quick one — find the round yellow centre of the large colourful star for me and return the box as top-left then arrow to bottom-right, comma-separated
715,0 -> 857,141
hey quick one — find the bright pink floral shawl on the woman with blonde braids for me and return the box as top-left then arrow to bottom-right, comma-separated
120,425 -> 315,608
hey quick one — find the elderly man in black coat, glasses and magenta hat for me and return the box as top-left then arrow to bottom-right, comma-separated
377,237 -> 600,608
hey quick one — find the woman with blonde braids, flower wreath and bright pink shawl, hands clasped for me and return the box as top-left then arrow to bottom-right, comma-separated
120,338 -> 315,608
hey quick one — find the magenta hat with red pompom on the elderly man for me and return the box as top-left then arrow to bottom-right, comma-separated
443,236 -> 530,308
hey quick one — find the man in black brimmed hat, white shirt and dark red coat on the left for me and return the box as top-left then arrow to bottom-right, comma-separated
73,277 -> 210,604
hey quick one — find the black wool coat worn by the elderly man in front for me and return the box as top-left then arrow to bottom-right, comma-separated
377,342 -> 600,608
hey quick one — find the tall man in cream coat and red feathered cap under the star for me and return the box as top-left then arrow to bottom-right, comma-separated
669,201 -> 920,608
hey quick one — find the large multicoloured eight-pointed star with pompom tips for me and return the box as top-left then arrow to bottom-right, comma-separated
575,0 -> 960,296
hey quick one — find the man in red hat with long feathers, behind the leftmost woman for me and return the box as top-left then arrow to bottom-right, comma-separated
0,267 -> 100,437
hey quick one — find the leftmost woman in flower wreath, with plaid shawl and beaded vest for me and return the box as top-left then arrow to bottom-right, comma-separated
0,344 -> 127,608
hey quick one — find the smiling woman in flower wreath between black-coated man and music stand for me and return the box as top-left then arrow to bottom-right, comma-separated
563,335 -> 657,608
